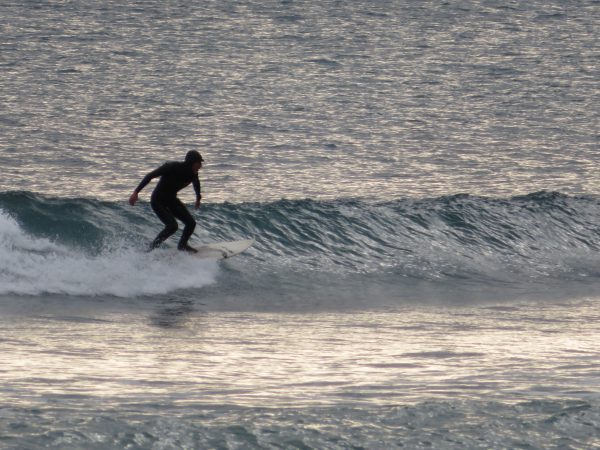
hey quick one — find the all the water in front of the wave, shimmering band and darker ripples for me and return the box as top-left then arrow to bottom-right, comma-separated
0,298 -> 600,449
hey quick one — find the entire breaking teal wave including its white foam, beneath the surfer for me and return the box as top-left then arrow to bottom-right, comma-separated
0,192 -> 600,296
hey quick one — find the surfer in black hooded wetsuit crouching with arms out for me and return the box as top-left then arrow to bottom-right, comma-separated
129,150 -> 204,253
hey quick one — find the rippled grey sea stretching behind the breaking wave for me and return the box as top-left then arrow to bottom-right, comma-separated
0,0 -> 600,202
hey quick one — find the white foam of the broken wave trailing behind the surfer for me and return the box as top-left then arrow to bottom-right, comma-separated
0,211 -> 218,297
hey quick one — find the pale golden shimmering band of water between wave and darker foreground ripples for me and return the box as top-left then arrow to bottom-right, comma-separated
0,301 -> 600,407
